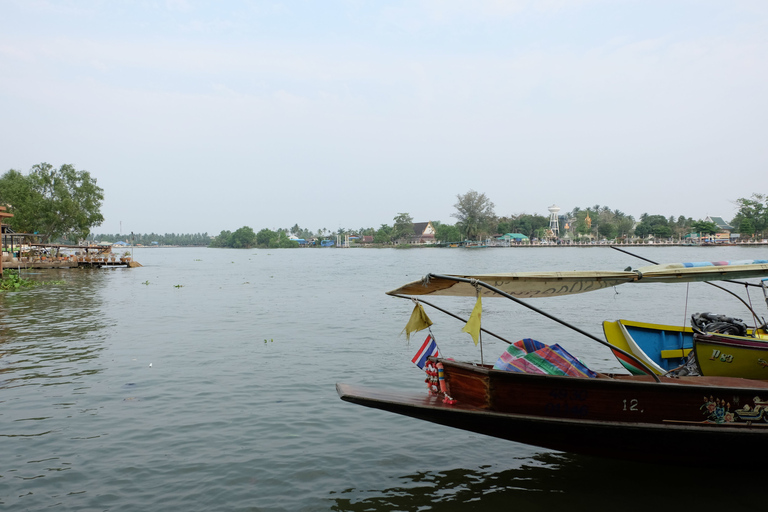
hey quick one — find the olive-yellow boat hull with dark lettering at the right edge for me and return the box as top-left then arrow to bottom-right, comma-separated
693,333 -> 768,380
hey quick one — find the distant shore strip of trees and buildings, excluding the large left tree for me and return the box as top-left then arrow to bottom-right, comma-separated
89,190 -> 768,249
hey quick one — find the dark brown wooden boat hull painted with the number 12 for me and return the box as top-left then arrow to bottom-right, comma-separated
337,360 -> 768,465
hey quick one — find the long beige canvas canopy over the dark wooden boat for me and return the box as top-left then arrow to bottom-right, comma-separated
387,260 -> 768,298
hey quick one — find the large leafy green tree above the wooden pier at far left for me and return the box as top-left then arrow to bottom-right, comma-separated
0,163 -> 104,242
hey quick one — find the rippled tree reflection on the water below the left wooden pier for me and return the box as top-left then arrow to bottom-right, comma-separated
0,271 -> 109,492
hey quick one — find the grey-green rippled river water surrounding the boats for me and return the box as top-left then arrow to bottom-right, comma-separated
0,247 -> 768,511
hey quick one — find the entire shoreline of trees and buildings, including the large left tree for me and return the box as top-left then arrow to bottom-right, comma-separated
0,168 -> 768,249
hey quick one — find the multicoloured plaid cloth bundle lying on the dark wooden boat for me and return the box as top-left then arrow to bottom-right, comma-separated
493,338 -> 597,379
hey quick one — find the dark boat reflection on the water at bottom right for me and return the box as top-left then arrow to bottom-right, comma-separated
330,450 -> 759,512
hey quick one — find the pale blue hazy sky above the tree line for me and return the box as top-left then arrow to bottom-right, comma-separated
0,0 -> 768,235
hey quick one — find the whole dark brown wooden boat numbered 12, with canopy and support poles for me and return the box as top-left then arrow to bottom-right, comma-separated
337,262 -> 768,466
